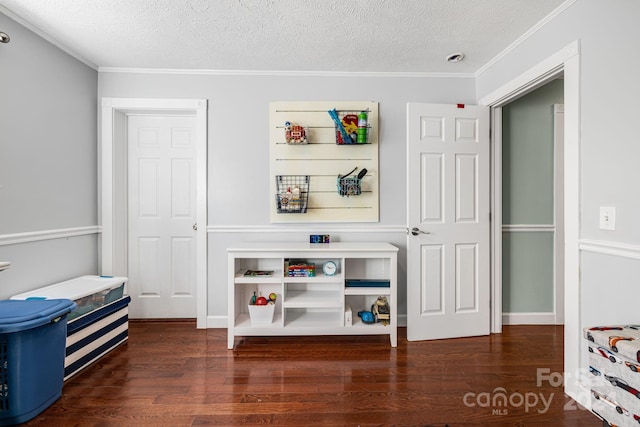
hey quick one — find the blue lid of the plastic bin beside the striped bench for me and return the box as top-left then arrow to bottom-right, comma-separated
0,299 -> 76,334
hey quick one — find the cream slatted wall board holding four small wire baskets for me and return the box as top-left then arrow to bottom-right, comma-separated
269,101 -> 379,223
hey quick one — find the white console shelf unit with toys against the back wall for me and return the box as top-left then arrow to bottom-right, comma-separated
227,242 -> 398,349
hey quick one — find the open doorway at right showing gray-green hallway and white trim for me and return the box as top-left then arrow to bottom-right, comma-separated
496,78 -> 564,325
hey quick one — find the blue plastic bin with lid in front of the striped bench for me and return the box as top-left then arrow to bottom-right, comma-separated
0,299 -> 75,426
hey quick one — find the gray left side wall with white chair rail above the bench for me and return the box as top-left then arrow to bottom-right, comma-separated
0,13 -> 98,299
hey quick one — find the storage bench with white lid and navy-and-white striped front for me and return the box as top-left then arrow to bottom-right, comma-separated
11,276 -> 131,380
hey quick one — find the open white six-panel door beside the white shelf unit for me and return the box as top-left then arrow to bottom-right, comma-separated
407,103 -> 490,341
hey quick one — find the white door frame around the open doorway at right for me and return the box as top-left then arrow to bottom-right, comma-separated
479,40 -> 590,407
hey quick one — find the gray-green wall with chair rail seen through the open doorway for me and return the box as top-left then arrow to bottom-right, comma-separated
502,79 -> 564,313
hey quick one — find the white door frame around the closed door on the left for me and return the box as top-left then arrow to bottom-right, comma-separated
99,98 -> 207,328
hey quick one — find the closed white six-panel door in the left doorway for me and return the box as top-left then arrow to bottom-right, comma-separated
128,115 -> 197,318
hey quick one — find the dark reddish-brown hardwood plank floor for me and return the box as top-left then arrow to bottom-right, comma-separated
25,321 -> 602,427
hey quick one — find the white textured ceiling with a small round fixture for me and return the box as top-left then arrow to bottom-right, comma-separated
0,0 -> 564,73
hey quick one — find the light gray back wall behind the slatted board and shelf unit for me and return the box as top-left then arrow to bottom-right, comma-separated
98,72 -> 475,319
